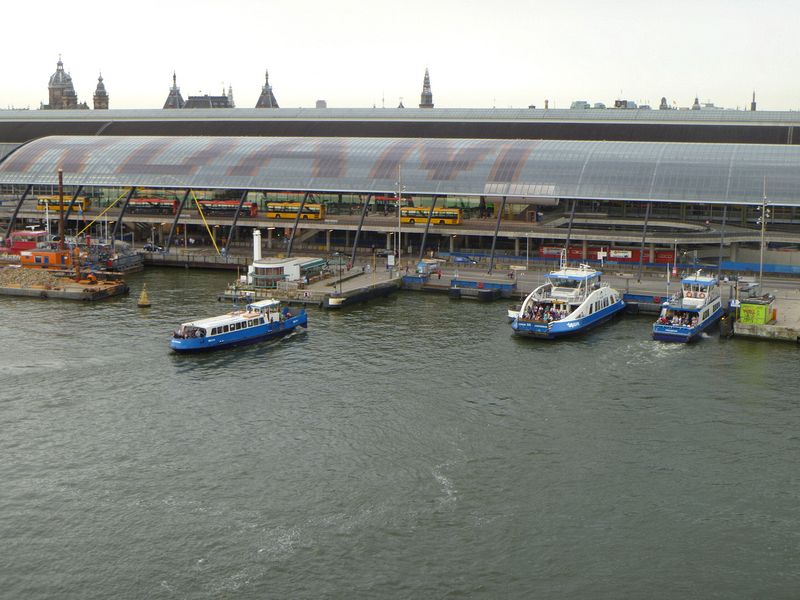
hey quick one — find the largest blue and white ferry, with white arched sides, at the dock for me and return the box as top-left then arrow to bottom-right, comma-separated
509,256 -> 625,339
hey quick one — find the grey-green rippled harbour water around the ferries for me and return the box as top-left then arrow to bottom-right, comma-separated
0,269 -> 800,600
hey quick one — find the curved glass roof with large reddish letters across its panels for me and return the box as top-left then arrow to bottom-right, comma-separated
0,136 -> 800,206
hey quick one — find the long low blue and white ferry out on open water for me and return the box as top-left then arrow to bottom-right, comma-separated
169,299 -> 308,352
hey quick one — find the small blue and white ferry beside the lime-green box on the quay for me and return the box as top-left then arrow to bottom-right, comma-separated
653,271 -> 723,343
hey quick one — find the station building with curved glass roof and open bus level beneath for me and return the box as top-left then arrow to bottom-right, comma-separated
0,127 -> 800,274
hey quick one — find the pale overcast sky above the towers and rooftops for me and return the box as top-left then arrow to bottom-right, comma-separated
0,0 -> 800,110
